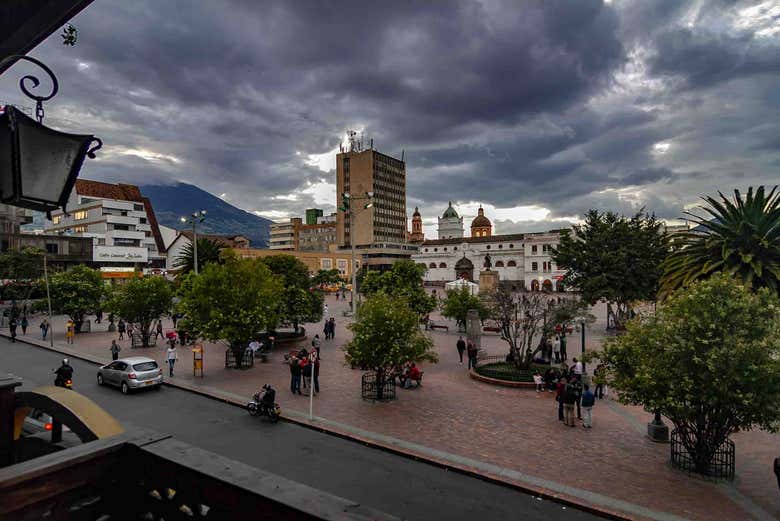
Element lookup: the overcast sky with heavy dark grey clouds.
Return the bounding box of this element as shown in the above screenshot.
[0,0,780,236]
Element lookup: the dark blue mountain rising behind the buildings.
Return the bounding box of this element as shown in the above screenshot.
[140,183,271,248]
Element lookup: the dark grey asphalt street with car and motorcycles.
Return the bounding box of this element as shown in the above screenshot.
[0,338,599,521]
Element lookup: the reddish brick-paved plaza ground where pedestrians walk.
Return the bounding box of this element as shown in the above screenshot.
[12,297,780,520]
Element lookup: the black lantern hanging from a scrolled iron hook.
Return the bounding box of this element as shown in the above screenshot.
[0,55,103,217]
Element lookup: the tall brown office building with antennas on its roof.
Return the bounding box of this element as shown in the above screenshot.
[336,139,417,268]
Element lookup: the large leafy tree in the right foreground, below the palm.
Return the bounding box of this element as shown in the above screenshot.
[600,274,780,474]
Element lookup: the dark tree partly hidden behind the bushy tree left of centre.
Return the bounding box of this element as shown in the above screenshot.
[262,255,323,331]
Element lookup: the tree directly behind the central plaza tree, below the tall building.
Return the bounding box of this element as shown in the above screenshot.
[360,260,436,318]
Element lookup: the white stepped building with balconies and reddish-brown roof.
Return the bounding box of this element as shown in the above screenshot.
[44,179,165,272]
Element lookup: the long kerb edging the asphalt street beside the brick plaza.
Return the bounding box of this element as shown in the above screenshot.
[6,333,639,521]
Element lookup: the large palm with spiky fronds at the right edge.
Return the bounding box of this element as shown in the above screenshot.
[660,186,780,297]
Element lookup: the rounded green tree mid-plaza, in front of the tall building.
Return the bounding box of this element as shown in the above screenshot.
[343,292,438,394]
